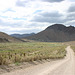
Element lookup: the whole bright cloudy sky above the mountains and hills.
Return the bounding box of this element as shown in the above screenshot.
[0,0,75,34]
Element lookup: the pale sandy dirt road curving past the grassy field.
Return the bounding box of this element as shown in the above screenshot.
[2,46,75,75]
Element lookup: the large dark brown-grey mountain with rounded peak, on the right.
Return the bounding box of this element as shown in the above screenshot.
[26,24,75,42]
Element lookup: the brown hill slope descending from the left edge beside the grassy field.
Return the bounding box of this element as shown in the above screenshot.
[0,32,23,42]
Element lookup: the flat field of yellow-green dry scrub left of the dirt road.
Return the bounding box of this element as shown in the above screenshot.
[0,42,66,65]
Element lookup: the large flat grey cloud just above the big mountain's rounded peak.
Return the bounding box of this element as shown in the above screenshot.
[31,12,64,23]
